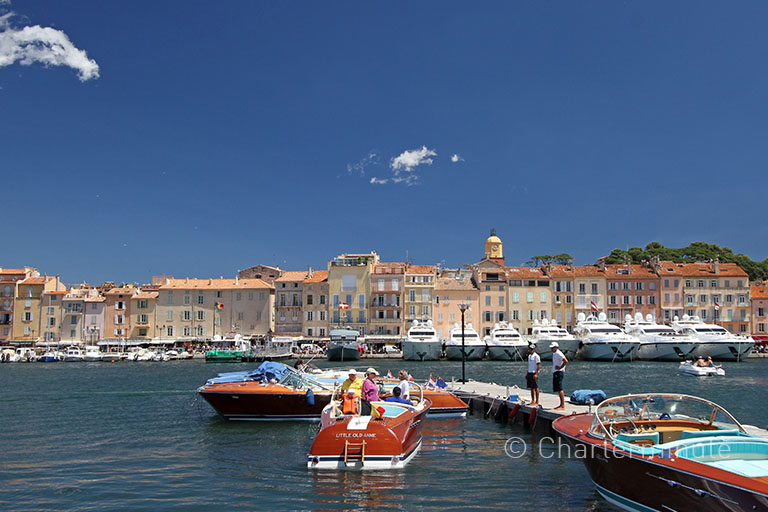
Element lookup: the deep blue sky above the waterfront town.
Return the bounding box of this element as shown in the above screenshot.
[0,0,768,282]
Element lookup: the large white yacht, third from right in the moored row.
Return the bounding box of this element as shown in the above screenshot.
[575,313,640,362]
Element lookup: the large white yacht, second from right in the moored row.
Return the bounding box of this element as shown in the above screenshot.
[624,313,698,361]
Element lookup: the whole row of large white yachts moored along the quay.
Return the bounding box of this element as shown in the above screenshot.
[403,313,754,362]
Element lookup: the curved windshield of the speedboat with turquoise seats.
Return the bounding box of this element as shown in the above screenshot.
[590,393,744,437]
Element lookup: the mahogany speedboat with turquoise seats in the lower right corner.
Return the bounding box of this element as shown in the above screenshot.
[553,393,768,511]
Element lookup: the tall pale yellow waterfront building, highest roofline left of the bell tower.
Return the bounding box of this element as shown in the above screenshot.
[328,251,379,335]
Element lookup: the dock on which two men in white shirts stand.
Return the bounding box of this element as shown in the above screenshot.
[446,380,768,438]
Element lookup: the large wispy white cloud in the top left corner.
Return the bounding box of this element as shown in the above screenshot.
[0,4,99,82]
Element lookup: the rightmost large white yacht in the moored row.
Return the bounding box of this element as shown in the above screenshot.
[672,315,755,361]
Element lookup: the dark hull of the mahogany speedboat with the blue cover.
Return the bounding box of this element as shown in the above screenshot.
[198,382,331,421]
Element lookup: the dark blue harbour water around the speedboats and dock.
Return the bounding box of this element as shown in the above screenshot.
[0,360,768,511]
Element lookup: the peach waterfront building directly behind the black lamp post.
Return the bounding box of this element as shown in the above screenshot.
[432,268,480,339]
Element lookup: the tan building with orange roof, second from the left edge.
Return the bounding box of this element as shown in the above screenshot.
[10,276,66,344]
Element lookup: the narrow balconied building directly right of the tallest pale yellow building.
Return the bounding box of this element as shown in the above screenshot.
[368,262,406,336]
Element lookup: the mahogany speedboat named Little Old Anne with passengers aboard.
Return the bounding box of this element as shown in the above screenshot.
[307,386,432,469]
